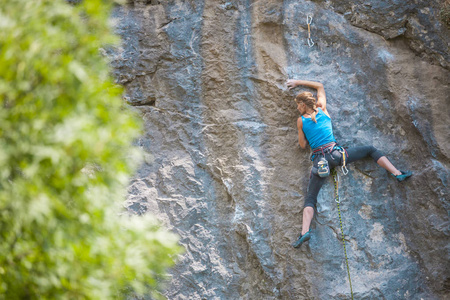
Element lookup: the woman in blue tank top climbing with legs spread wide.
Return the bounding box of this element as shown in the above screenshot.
[287,79,412,248]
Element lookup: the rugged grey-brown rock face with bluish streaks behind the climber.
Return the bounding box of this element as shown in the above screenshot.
[108,0,450,299]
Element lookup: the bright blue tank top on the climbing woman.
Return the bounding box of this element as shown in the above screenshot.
[302,108,336,149]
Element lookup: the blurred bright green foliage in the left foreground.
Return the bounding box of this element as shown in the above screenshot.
[0,0,180,299]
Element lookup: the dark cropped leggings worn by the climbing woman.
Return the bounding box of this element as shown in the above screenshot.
[304,146,383,208]
